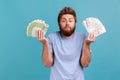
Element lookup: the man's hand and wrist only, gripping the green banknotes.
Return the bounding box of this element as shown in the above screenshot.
[36,30,48,45]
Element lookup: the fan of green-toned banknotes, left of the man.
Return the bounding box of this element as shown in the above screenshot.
[27,19,48,37]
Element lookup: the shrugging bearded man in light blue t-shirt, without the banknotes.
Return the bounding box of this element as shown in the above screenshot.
[37,7,96,80]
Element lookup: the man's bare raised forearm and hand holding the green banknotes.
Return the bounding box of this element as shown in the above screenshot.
[36,30,53,67]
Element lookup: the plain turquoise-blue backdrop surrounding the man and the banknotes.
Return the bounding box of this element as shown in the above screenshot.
[0,0,120,80]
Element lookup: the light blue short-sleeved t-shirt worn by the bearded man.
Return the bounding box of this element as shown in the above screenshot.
[47,32,86,80]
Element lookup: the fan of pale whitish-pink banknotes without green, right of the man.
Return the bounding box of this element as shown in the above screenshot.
[83,17,106,36]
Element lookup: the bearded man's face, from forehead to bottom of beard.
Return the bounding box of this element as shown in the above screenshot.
[59,14,76,37]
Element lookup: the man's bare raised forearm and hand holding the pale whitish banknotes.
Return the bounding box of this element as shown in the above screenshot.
[80,33,96,67]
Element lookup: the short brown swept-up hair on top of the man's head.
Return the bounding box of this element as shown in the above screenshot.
[58,7,77,23]
